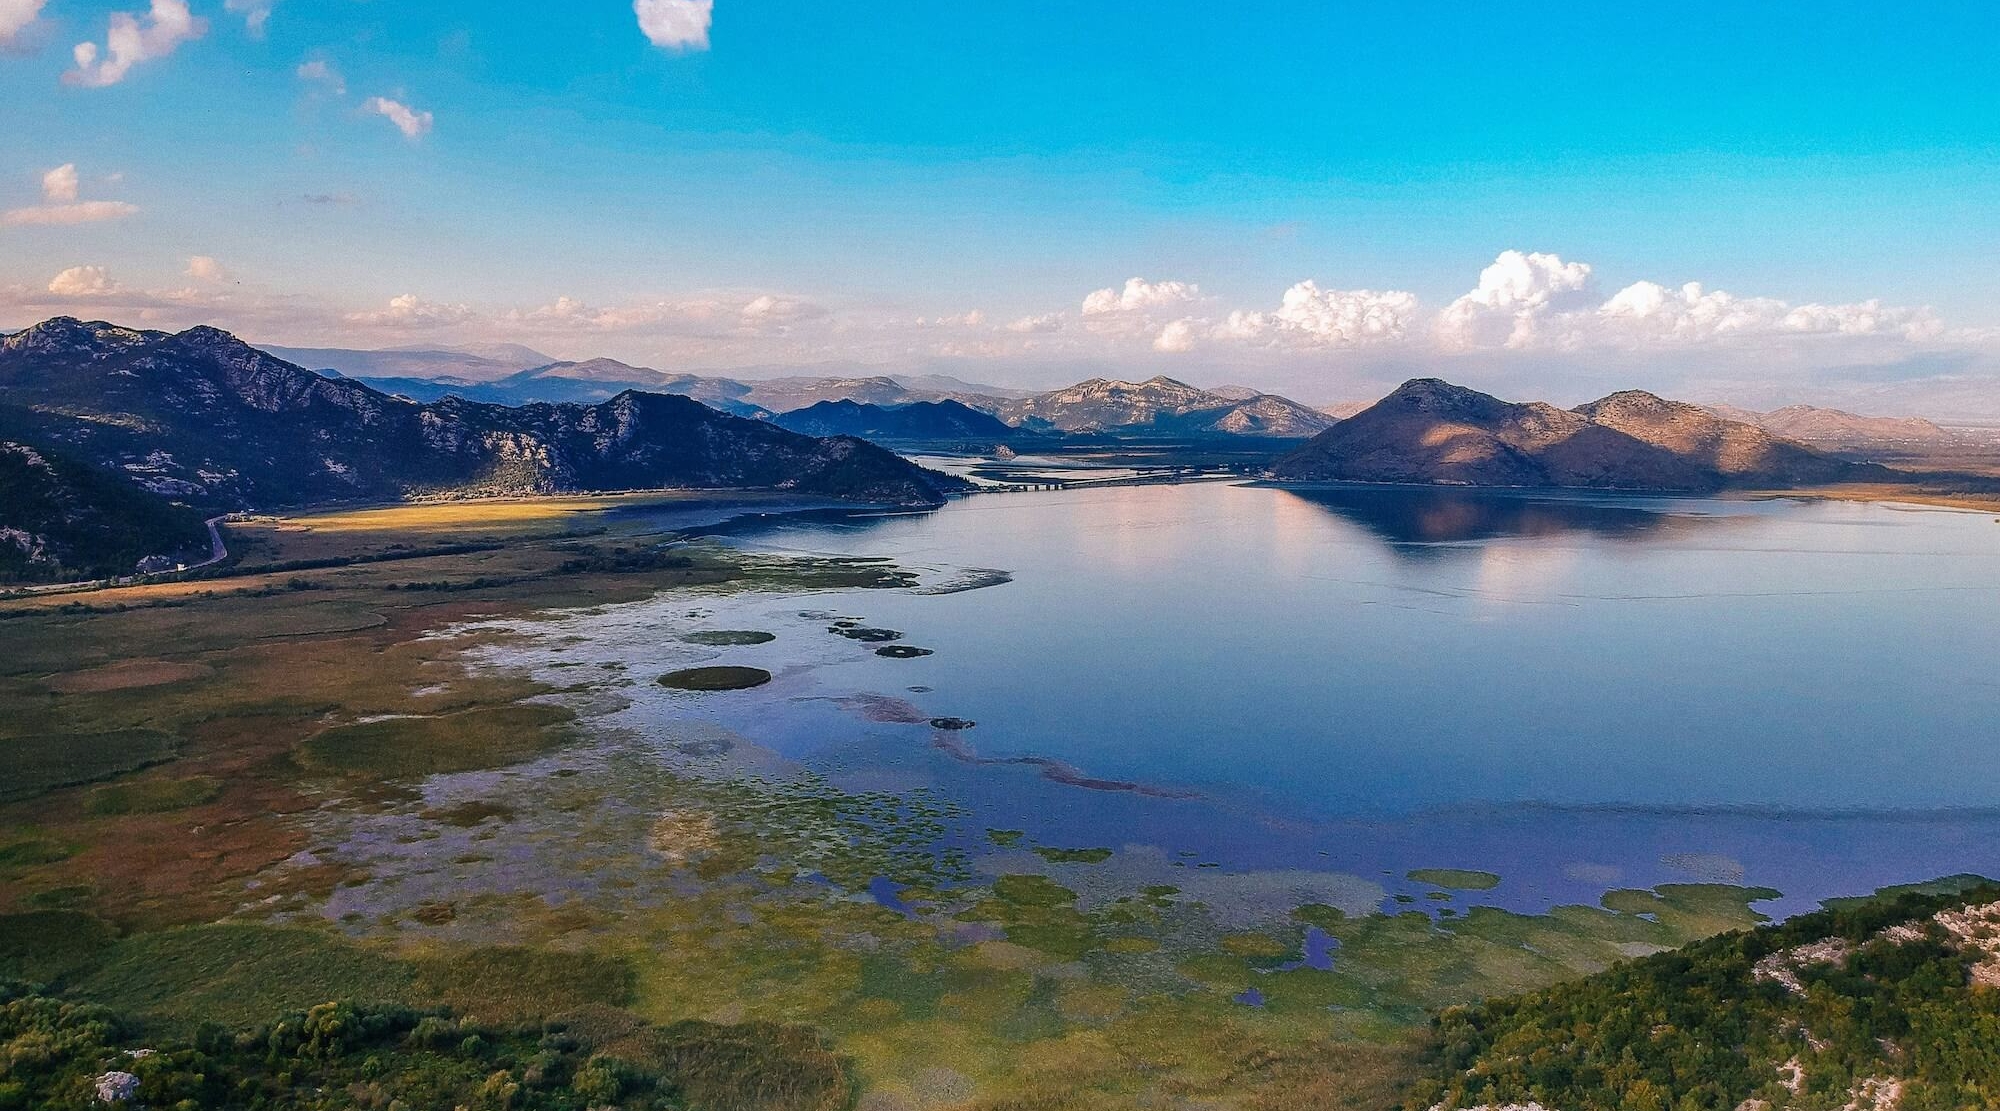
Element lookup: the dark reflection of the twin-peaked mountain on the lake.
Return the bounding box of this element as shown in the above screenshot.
[1282,486,1702,556]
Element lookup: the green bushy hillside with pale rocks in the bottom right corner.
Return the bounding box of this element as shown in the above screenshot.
[1406,877,2000,1111]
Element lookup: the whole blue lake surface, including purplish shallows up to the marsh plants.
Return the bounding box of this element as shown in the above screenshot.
[524,484,2000,909]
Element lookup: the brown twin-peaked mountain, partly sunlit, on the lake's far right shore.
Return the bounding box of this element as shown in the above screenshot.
[1272,378,1890,492]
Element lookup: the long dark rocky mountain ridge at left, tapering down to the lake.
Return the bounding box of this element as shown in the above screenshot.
[0,318,958,510]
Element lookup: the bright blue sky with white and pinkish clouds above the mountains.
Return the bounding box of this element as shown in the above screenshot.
[0,0,2000,418]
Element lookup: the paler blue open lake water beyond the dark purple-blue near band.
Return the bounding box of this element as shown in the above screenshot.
[696,484,2000,811]
